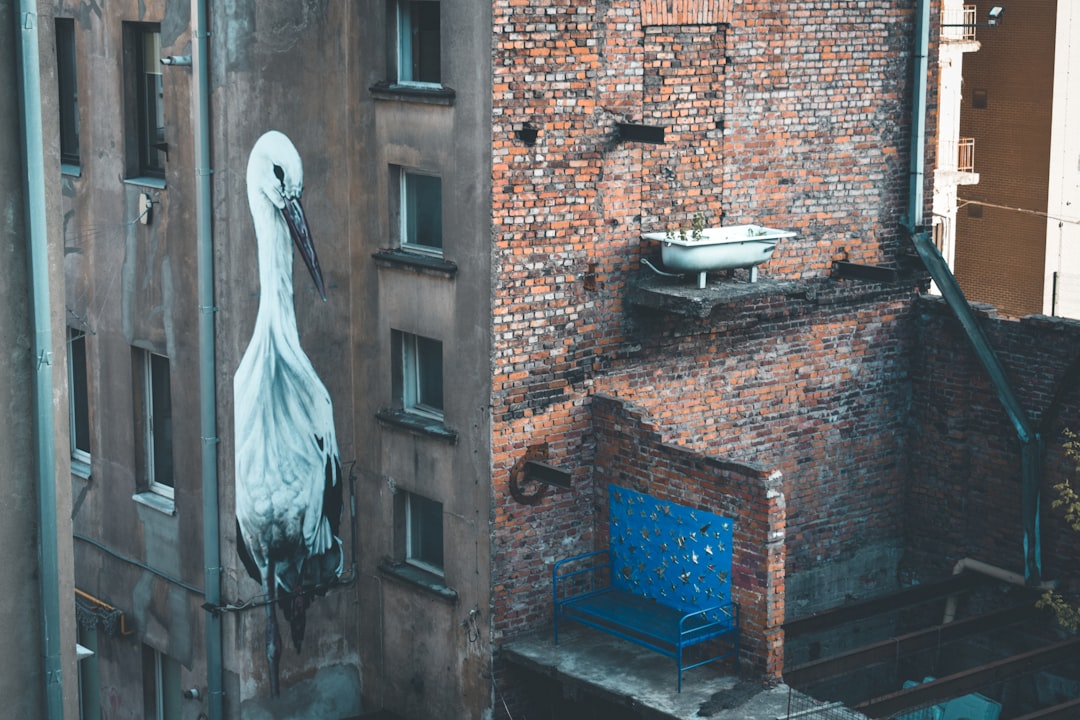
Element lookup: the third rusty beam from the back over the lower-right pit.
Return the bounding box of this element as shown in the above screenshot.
[854,638,1080,718]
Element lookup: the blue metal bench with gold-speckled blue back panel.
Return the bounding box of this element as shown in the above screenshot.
[552,486,739,692]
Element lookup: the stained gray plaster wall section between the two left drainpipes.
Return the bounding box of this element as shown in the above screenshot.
[55,0,232,720]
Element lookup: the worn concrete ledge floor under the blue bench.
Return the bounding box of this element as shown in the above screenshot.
[502,624,856,720]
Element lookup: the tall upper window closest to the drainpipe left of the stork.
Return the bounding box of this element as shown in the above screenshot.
[125,23,168,178]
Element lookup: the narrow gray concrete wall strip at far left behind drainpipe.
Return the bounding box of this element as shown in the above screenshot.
[0,2,79,719]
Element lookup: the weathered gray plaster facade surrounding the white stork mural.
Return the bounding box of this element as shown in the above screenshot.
[58,0,491,718]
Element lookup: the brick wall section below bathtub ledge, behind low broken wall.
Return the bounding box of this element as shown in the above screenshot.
[609,283,910,578]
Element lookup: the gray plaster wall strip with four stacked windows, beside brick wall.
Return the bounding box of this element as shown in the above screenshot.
[350,0,494,718]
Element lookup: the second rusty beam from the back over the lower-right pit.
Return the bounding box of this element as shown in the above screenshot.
[784,604,1038,688]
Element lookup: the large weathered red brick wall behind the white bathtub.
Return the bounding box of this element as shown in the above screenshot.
[490,0,937,708]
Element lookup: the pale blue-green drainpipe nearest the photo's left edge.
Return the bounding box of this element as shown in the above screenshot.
[18,0,64,720]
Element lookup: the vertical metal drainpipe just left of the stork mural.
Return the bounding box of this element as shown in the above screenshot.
[191,0,224,720]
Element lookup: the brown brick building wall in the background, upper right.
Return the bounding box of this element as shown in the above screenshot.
[955,0,1054,315]
